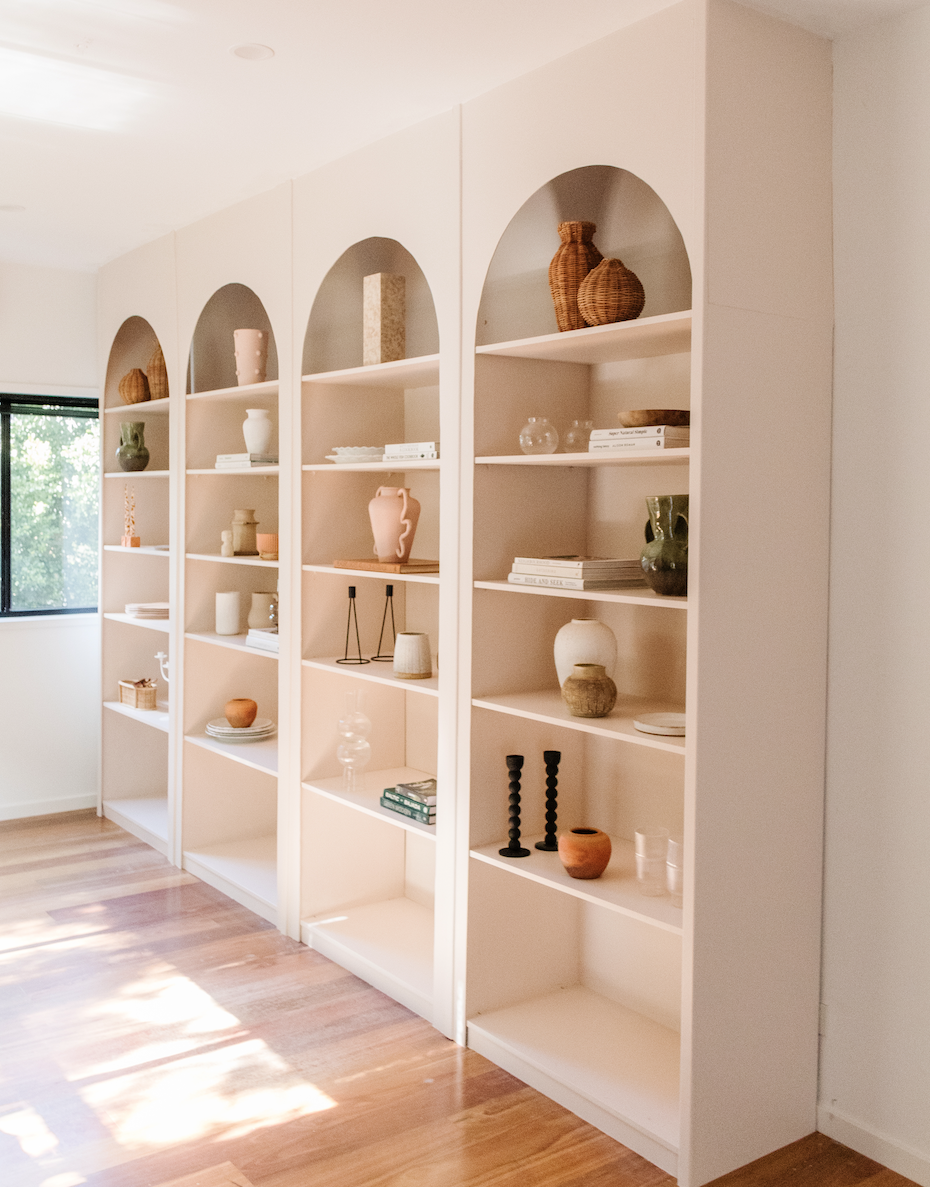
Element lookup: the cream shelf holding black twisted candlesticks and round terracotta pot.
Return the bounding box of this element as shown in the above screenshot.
[472,833,682,935]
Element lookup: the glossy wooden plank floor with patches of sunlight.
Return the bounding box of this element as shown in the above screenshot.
[0,813,909,1187]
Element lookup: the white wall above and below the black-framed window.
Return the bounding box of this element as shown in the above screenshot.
[0,262,100,820]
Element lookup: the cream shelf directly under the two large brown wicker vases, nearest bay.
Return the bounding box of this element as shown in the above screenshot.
[475,310,691,363]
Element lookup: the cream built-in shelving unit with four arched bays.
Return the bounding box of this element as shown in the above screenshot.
[100,0,830,1187]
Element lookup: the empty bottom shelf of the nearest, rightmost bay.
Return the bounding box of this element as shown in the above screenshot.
[468,985,681,1174]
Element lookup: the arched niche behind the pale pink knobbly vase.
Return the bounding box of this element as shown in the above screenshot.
[188,284,278,395]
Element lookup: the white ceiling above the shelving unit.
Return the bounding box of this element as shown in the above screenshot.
[0,0,920,269]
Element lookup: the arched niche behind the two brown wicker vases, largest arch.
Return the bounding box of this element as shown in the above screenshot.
[475,165,691,347]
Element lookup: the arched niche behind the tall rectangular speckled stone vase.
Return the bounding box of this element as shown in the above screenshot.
[300,237,439,375]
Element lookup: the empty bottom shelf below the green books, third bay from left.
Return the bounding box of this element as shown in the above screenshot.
[300,899,434,1017]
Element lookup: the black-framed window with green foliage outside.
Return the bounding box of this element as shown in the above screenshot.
[0,395,100,617]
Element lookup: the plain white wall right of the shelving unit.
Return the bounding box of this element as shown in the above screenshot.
[821,7,930,1185]
